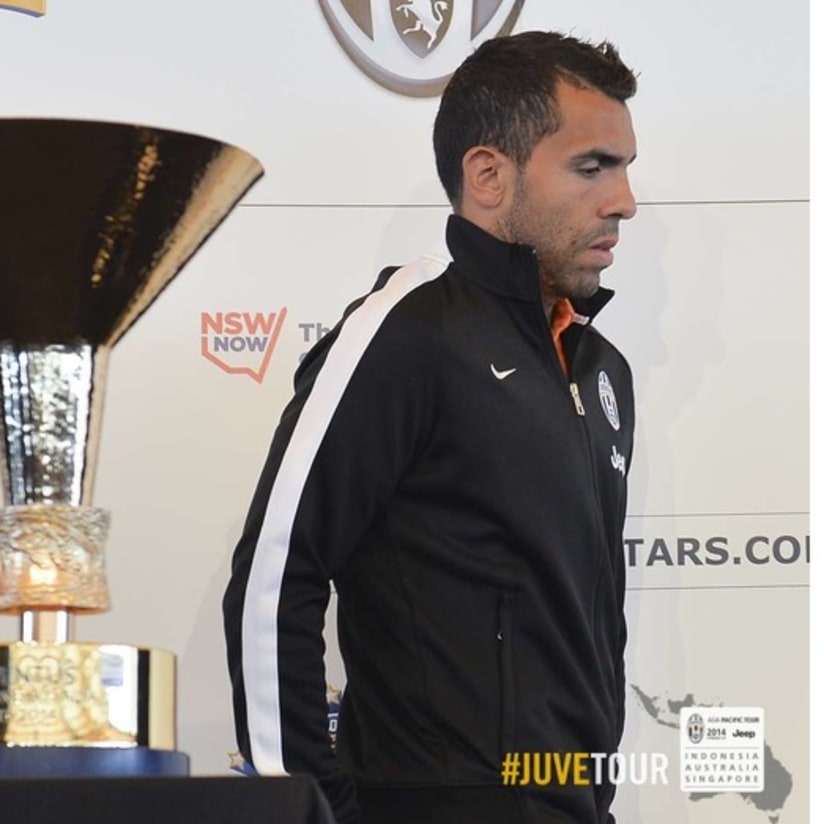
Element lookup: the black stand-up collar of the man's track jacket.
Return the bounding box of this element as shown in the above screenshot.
[446,214,615,323]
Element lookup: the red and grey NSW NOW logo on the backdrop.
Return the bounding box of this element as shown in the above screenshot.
[200,306,286,383]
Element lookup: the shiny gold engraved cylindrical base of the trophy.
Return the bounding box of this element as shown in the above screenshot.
[0,641,180,760]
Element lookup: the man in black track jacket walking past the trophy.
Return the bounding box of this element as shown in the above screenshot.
[224,32,635,824]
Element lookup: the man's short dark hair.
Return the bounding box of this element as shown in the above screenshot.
[433,31,636,206]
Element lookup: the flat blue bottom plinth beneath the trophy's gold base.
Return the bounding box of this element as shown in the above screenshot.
[0,747,189,778]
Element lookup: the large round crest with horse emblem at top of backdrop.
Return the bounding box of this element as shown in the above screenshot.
[318,0,524,97]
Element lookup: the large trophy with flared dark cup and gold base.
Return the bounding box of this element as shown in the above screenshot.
[0,119,263,772]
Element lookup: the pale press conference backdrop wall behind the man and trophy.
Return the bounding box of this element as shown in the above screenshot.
[0,0,810,824]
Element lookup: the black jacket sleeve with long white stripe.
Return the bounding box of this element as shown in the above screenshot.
[223,259,444,824]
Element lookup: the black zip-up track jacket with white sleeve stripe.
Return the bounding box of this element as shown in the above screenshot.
[224,215,634,824]
